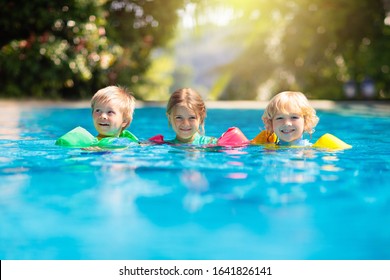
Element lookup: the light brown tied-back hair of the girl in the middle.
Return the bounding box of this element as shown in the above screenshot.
[167,88,206,134]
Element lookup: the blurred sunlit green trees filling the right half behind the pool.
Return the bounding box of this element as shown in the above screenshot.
[204,0,390,99]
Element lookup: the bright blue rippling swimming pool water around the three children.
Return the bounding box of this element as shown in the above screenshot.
[0,104,390,260]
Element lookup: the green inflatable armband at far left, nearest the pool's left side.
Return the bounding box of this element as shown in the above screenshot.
[55,126,98,148]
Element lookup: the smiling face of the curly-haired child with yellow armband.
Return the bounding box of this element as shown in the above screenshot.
[272,112,305,142]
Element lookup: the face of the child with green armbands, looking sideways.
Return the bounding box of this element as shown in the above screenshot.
[92,102,127,138]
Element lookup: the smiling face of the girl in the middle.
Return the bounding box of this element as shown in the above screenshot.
[168,105,200,143]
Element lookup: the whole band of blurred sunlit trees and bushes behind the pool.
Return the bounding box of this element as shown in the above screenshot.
[0,0,390,100]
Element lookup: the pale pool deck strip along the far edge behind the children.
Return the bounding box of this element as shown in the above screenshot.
[0,99,390,116]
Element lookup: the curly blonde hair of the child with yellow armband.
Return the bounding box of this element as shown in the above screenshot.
[262,91,319,135]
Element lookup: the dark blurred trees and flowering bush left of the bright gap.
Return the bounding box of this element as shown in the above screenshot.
[0,0,192,99]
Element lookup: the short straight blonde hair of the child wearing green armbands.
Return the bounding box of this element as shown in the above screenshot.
[91,86,135,130]
